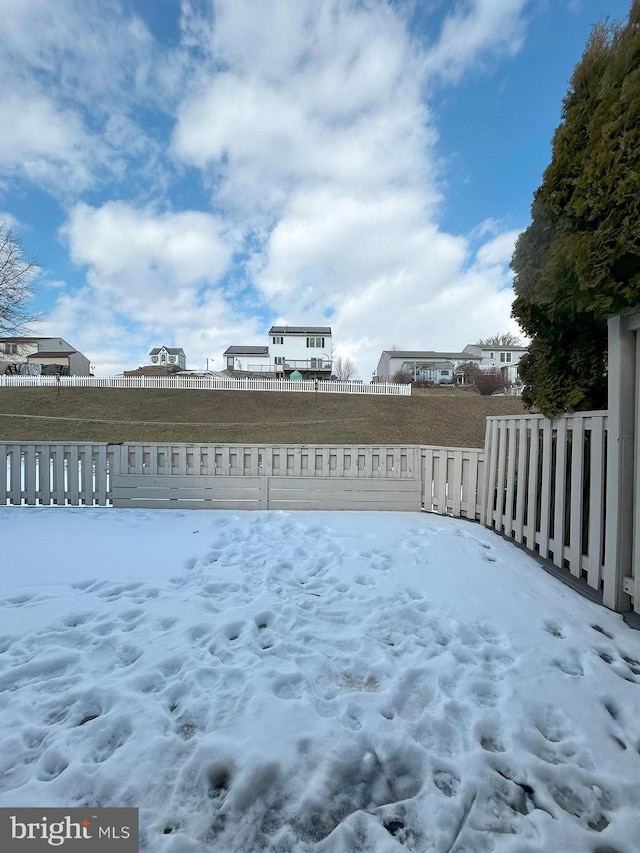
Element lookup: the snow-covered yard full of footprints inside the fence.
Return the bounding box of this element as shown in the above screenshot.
[0,507,640,853]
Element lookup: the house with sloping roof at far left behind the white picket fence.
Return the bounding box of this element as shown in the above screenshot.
[0,336,91,376]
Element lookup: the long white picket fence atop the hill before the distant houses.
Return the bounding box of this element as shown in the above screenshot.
[0,375,411,397]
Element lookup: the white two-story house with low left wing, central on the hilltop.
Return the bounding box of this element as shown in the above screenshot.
[224,326,332,379]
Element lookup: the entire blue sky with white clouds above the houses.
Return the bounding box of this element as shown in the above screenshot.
[0,0,630,380]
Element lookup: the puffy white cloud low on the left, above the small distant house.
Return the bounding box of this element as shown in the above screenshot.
[41,202,256,373]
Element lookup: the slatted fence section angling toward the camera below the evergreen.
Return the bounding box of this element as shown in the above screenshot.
[484,412,606,590]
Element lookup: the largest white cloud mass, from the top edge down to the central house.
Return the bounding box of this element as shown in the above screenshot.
[169,0,526,376]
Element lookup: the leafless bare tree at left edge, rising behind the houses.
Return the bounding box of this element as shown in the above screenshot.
[0,222,40,334]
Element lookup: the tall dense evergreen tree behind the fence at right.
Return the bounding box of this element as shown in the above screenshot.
[511,0,640,416]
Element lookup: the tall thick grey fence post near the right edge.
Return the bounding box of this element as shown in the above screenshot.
[603,314,637,611]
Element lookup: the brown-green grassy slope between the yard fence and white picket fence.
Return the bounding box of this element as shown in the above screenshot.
[0,387,524,447]
